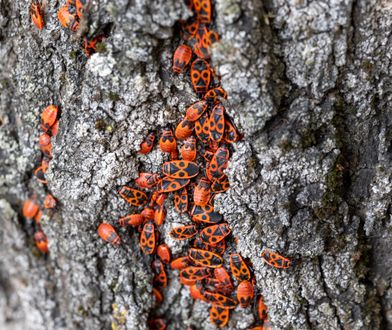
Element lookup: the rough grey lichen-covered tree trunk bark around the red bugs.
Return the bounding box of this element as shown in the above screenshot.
[0,0,392,329]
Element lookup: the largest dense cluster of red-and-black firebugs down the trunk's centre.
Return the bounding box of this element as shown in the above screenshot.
[98,0,291,330]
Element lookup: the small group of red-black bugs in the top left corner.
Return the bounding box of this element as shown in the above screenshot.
[30,0,109,56]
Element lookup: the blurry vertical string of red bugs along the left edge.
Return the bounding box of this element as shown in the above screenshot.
[22,105,59,253]
